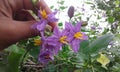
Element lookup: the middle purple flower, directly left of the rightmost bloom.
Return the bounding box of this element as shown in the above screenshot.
[47,27,68,54]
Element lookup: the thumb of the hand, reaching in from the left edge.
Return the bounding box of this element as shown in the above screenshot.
[0,18,37,50]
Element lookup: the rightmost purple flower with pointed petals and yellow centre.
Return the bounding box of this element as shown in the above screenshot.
[65,22,88,53]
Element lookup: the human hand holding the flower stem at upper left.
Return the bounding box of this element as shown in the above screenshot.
[0,0,56,50]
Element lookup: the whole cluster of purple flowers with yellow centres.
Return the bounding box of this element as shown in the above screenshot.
[33,10,88,64]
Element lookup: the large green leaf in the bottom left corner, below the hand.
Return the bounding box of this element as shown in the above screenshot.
[7,45,25,72]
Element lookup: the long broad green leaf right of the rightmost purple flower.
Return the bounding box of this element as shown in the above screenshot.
[88,34,114,53]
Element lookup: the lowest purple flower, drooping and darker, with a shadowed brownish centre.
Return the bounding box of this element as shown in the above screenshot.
[38,36,55,64]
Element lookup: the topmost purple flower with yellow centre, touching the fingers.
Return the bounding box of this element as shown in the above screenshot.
[32,10,58,31]
